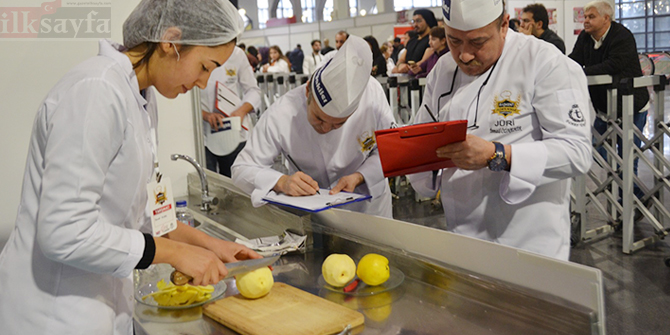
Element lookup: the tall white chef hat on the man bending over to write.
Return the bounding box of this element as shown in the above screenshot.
[310,35,372,118]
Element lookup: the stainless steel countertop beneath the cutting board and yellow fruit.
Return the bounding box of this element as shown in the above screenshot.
[135,210,595,335]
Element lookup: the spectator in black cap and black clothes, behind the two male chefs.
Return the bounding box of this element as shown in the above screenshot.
[393,8,437,73]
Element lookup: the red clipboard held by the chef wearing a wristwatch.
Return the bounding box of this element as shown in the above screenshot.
[375,120,468,177]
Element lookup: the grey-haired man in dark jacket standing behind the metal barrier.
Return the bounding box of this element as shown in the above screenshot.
[569,0,649,197]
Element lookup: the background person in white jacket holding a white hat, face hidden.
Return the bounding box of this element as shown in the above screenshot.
[200,41,261,177]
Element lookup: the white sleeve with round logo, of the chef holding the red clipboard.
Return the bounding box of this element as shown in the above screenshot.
[500,53,592,204]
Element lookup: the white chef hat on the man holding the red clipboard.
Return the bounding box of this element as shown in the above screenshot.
[442,0,503,31]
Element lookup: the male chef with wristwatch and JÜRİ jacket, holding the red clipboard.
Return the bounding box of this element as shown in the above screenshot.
[409,0,591,260]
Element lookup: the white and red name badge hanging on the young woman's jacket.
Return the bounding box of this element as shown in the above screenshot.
[147,177,177,236]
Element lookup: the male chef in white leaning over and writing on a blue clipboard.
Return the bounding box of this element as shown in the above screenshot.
[233,36,394,218]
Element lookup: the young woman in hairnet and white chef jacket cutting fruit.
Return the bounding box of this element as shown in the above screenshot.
[0,0,260,334]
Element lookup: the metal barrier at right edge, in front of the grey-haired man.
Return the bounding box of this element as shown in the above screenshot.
[571,75,670,254]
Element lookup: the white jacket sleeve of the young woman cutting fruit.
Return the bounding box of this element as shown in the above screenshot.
[36,79,145,277]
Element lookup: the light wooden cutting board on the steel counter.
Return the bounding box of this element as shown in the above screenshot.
[204,283,365,335]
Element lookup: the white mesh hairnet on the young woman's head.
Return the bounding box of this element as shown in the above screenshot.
[123,0,244,49]
